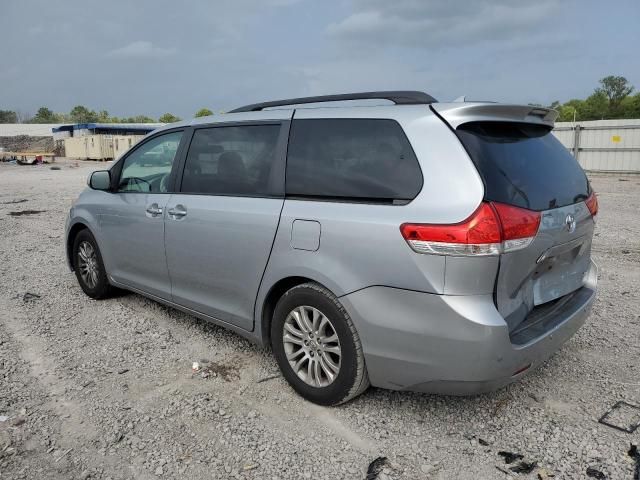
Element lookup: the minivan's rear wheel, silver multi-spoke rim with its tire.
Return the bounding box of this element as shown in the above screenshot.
[271,283,369,405]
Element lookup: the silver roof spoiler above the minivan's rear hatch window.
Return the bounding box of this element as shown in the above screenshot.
[431,102,558,129]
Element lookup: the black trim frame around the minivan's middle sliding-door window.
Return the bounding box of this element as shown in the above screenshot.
[174,119,291,198]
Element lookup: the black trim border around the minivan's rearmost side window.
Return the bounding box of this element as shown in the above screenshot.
[284,116,424,207]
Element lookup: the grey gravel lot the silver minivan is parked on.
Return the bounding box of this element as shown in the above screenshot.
[0,161,640,479]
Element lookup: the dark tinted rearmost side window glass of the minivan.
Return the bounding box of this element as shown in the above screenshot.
[286,119,422,203]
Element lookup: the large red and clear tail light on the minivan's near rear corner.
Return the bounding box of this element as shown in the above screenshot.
[400,202,540,256]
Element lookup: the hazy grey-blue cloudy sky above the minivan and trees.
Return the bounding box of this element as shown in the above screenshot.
[0,0,640,118]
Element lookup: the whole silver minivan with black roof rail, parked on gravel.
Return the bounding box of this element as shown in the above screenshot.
[66,91,598,405]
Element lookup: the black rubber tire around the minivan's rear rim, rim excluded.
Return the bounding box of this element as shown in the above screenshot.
[271,283,369,405]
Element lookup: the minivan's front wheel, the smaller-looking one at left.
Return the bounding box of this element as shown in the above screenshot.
[73,230,113,299]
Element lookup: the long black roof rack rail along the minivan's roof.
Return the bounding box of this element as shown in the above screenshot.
[229,90,437,113]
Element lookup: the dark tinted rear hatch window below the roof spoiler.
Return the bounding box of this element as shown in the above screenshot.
[456,122,589,211]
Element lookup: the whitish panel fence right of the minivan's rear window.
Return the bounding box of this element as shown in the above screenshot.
[553,119,640,173]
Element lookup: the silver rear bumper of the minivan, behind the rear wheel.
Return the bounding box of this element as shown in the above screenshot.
[341,263,597,395]
